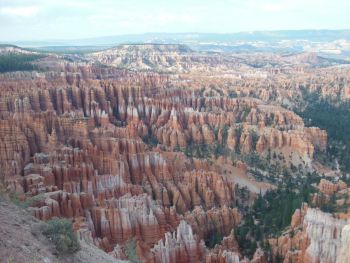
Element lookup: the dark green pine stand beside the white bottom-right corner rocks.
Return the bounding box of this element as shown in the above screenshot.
[235,175,318,257]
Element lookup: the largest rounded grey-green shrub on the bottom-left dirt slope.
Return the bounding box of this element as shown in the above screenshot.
[43,218,79,254]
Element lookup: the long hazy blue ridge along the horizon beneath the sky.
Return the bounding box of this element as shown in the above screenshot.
[4,29,350,46]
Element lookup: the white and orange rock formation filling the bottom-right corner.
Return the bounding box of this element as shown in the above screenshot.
[272,205,349,263]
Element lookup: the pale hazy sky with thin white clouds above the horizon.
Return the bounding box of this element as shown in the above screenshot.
[0,0,350,41]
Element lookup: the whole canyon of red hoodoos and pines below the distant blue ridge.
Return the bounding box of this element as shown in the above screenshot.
[0,43,350,263]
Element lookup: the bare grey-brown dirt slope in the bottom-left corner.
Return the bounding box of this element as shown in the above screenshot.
[0,200,123,263]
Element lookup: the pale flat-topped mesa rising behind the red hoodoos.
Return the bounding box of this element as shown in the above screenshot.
[88,44,238,72]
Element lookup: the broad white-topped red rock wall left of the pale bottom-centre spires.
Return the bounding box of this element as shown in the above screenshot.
[87,195,178,250]
